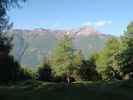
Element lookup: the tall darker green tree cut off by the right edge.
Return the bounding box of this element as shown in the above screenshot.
[115,22,133,77]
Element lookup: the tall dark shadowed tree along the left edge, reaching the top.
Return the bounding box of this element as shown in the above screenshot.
[0,0,25,83]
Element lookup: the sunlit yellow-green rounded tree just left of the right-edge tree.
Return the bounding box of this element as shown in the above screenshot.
[96,37,120,79]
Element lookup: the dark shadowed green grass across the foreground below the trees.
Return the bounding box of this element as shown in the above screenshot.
[0,80,133,100]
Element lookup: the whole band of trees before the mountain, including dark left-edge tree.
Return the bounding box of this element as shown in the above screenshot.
[0,0,133,84]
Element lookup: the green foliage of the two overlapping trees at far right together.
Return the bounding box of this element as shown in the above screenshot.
[92,22,133,80]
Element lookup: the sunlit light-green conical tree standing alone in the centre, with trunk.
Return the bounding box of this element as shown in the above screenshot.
[51,35,81,83]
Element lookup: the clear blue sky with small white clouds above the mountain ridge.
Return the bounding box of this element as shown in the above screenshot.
[9,0,133,36]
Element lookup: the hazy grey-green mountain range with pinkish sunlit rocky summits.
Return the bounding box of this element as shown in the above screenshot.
[10,26,110,66]
